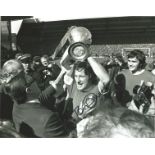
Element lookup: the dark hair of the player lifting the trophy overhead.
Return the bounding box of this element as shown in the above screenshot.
[74,61,97,84]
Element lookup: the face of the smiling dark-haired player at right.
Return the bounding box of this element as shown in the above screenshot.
[128,57,140,73]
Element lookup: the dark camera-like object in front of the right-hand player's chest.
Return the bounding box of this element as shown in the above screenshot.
[133,81,153,114]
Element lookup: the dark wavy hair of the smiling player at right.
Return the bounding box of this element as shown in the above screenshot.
[127,49,146,69]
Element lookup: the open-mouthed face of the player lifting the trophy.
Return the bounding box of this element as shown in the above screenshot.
[74,69,89,91]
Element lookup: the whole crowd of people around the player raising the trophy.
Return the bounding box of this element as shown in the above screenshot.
[0,26,155,138]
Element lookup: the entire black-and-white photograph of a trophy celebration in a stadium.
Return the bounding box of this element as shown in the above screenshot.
[0,0,155,154]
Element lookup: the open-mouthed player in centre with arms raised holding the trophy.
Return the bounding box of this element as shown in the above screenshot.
[68,57,109,121]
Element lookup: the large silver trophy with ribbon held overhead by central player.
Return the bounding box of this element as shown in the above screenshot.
[52,26,92,61]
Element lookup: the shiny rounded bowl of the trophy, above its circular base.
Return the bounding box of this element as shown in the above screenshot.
[69,27,92,44]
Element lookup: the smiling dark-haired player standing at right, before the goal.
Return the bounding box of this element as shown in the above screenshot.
[115,49,155,115]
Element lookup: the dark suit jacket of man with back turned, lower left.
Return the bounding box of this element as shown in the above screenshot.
[13,88,67,137]
